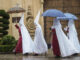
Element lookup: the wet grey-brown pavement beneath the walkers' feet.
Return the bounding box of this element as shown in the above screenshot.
[0,54,80,60]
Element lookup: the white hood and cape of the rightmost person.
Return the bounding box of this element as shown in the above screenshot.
[67,20,80,53]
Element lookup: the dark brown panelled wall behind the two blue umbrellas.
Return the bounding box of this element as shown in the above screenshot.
[43,0,80,43]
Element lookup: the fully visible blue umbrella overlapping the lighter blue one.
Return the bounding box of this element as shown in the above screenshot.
[42,9,65,17]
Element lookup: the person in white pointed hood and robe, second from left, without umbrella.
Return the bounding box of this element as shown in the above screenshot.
[34,11,48,54]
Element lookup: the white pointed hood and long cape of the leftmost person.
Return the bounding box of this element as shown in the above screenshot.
[19,14,34,54]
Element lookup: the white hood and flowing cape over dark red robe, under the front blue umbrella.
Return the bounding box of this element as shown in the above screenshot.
[53,20,78,57]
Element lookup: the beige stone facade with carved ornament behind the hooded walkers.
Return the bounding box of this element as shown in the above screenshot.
[0,0,44,40]
